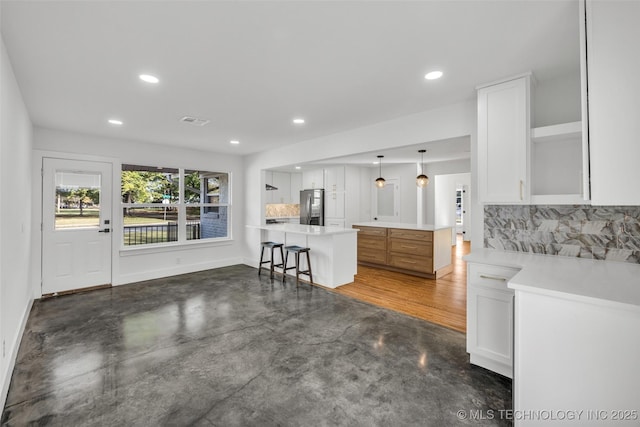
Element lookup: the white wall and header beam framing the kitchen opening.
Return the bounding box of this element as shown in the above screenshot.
[245,102,476,265]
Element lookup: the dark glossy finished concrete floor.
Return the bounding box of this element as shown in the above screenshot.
[2,265,511,426]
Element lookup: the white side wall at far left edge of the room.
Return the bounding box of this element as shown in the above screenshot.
[0,39,33,408]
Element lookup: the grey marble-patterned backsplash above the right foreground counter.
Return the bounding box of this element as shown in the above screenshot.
[484,205,640,263]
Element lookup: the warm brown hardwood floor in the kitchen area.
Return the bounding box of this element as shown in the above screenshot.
[335,236,470,332]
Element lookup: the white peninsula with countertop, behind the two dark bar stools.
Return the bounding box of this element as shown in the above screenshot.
[247,224,358,288]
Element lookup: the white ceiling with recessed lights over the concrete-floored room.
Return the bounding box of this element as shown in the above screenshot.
[1,0,579,161]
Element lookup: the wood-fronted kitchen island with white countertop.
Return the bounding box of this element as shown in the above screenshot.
[353,221,453,279]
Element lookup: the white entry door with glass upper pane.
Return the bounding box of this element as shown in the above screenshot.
[42,158,112,295]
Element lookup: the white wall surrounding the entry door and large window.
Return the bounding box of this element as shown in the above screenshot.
[32,128,245,288]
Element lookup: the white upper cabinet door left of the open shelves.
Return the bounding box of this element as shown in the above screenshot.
[478,74,531,203]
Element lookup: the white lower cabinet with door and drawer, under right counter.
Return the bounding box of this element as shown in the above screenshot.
[467,263,519,378]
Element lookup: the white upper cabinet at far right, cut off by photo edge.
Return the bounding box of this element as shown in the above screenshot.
[586,1,640,205]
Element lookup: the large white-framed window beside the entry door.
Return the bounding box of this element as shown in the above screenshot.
[121,165,230,246]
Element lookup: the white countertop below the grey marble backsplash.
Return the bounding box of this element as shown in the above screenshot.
[463,249,640,311]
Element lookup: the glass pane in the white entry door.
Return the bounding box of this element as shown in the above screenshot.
[55,171,101,230]
